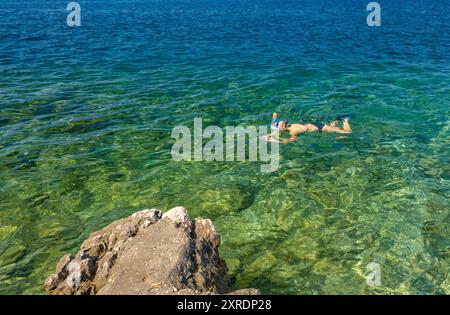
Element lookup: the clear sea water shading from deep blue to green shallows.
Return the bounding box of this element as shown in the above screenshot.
[0,0,450,294]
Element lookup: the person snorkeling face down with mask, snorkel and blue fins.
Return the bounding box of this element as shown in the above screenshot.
[264,113,354,143]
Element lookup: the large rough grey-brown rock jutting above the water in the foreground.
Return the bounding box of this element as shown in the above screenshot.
[44,207,259,294]
